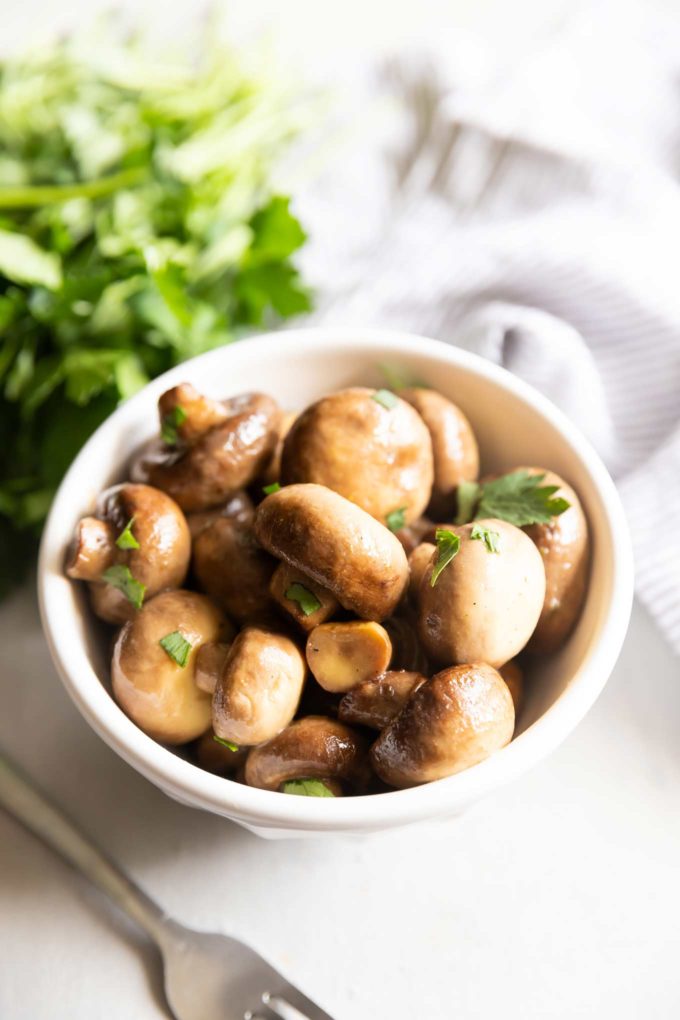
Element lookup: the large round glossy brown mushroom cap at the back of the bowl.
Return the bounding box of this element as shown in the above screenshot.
[281,387,432,524]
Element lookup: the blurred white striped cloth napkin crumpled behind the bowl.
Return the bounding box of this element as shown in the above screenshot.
[300,2,680,653]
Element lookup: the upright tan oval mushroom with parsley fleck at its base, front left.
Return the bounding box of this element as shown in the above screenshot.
[212,626,306,747]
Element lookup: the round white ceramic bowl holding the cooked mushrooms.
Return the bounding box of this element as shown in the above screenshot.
[39,329,633,836]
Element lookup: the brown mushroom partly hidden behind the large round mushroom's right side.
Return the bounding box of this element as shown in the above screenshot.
[399,387,479,517]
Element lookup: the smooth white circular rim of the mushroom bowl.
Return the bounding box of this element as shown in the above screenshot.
[38,326,633,832]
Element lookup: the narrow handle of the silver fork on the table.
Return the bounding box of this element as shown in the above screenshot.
[0,754,169,944]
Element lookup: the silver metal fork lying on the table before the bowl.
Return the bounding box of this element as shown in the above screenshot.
[0,755,332,1020]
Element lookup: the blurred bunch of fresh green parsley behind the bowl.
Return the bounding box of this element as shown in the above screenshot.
[0,29,310,592]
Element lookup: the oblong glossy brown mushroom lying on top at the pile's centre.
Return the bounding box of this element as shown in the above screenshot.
[254,485,409,620]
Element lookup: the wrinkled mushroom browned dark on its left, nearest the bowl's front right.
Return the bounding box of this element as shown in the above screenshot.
[371,662,515,787]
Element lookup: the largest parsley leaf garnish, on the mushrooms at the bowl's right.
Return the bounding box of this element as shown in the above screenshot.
[475,471,569,527]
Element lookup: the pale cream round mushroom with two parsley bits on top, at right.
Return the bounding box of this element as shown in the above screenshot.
[418,519,545,666]
